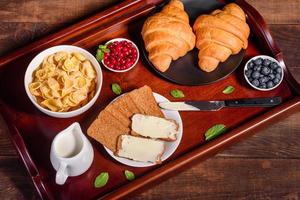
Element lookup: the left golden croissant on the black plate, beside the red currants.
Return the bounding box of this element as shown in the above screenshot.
[142,0,196,72]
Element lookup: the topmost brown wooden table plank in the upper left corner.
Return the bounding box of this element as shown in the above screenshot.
[0,0,120,24]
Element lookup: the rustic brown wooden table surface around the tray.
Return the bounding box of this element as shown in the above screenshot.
[0,0,300,200]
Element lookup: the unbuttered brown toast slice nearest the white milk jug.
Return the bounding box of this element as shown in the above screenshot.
[87,110,130,152]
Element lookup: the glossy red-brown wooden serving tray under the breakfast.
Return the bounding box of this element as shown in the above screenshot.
[0,0,300,200]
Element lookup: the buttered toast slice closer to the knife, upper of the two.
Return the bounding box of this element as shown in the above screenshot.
[131,114,178,140]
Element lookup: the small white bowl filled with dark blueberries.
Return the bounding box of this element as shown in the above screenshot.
[244,55,283,91]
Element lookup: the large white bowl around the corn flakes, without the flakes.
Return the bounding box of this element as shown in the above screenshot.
[24,45,103,118]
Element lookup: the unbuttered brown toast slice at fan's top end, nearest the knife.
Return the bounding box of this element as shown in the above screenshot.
[128,85,164,117]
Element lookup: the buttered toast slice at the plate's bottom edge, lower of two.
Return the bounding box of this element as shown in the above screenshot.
[116,135,165,163]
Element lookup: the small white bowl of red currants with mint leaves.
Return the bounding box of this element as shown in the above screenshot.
[96,38,139,72]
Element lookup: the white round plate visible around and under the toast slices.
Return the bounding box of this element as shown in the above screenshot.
[104,92,183,167]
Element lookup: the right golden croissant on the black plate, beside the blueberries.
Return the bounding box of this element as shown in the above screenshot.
[193,3,250,72]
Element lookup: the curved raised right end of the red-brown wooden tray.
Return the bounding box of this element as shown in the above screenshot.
[235,0,300,95]
